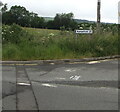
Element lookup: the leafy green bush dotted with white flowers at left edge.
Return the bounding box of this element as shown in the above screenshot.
[2,24,32,44]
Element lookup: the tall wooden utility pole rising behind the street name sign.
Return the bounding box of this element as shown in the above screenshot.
[97,0,101,33]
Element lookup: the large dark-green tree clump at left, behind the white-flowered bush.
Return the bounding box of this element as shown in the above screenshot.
[3,5,45,28]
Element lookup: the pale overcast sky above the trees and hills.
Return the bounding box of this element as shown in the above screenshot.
[2,0,120,23]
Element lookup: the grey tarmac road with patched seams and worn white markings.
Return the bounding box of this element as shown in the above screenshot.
[2,60,118,110]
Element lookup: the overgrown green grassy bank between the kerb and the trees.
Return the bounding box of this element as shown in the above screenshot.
[2,26,118,60]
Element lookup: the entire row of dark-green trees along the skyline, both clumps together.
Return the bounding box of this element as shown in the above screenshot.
[1,4,77,30]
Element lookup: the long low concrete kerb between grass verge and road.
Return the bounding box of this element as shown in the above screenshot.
[1,55,120,65]
